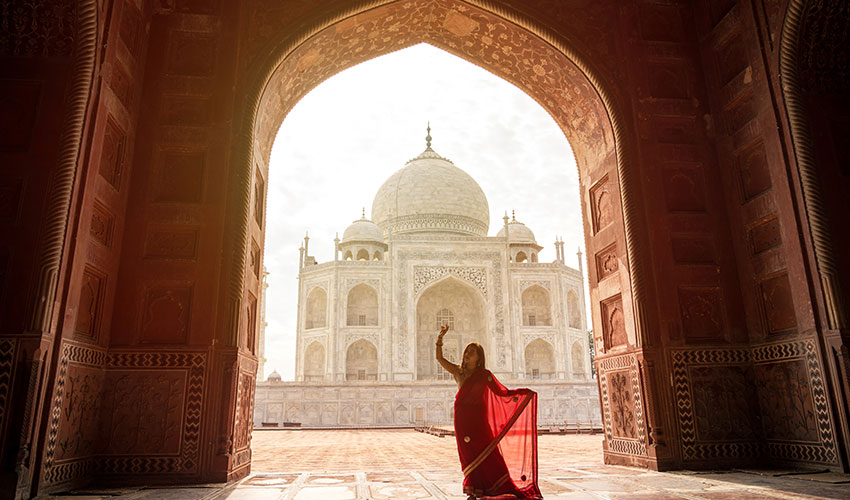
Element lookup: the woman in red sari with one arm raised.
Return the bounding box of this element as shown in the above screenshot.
[437,326,543,500]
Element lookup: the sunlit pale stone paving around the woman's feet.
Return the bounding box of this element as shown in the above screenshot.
[53,430,850,500]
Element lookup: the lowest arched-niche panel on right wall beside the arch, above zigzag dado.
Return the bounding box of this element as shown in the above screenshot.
[679,286,724,341]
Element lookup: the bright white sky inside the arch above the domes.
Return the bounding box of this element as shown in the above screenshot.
[263,44,590,380]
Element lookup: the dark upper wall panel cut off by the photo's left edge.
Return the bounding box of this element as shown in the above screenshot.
[0,79,41,151]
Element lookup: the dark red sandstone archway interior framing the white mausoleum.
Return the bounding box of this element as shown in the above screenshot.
[0,0,850,498]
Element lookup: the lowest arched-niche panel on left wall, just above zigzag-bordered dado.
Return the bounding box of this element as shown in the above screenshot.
[140,287,192,344]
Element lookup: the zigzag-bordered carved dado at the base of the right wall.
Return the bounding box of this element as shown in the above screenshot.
[670,339,838,464]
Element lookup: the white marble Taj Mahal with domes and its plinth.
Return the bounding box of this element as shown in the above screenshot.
[248,132,601,427]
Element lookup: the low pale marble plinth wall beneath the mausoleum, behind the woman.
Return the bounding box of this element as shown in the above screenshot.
[248,380,602,428]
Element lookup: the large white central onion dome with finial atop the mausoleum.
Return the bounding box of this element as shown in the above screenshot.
[372,143,490,236]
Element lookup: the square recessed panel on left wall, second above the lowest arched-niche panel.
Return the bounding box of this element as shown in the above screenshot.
[154,151,205,203]
